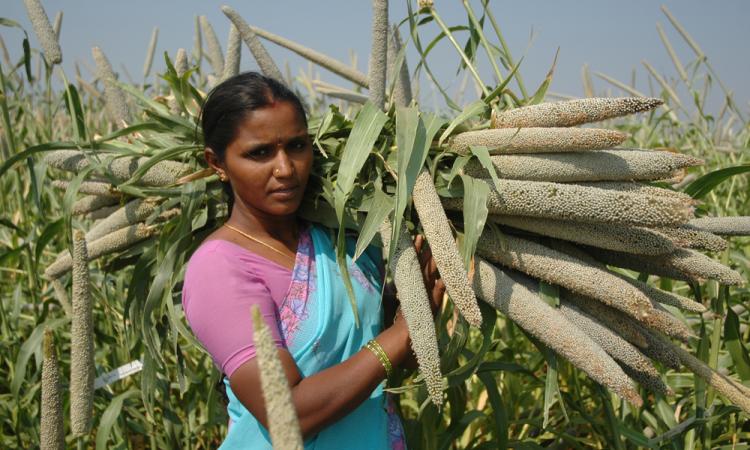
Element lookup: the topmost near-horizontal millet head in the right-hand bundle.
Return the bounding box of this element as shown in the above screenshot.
[492,97,664,128]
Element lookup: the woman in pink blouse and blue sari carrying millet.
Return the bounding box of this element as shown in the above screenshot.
[183,73,444,450]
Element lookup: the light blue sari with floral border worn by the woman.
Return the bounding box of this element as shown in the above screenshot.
[220,225,405,450]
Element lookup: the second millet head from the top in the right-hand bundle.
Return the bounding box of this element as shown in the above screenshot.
[448,128,628,155]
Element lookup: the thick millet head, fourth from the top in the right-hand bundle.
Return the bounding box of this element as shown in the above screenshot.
[443,179,693,226]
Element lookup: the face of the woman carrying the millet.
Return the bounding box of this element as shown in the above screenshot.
[217,101,313,221]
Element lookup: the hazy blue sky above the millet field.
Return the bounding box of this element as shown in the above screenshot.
[5,0,750,116]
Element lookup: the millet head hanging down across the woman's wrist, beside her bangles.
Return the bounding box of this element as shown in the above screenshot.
[380,220,443,406]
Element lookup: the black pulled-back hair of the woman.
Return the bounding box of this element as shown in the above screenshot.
[200,72,307,214]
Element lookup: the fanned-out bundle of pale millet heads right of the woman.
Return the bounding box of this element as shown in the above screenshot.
[432,98,750,411]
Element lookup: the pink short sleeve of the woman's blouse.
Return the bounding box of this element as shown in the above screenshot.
[182,242,286,376]
